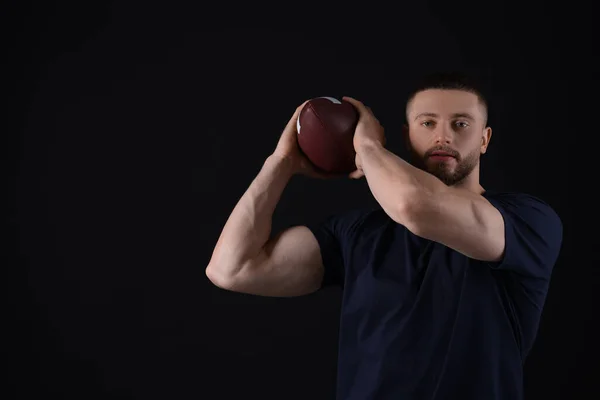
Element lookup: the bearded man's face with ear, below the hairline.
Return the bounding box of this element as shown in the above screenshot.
[407,89,491,186]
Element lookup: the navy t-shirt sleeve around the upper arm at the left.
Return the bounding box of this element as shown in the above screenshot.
[307,210,364,288]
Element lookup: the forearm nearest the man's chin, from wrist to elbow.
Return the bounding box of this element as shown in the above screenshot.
[358,143,444,227]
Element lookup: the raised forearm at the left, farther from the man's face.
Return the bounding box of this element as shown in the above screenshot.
[210,156,293,276]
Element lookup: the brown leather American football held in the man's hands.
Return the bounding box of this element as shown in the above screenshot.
[296,97,358,174]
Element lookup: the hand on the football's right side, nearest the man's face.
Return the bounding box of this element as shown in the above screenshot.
[342,96,385,179]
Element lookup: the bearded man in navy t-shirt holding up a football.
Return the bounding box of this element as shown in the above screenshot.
[206,75,562,400]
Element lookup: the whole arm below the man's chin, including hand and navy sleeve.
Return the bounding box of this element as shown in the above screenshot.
[344,97,562,268]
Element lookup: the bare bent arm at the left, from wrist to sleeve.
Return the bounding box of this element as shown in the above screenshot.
[206,155,324,297]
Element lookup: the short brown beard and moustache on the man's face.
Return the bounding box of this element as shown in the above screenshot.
[411,146,480,186]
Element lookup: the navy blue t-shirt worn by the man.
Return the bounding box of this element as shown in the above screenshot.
[309,192,562,400]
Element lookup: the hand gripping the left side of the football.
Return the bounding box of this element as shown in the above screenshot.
[272,100,338,179]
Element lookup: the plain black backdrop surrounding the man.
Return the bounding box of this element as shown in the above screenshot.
[3,2,600,399]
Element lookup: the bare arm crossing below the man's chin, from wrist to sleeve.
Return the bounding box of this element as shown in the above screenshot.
[357,141,505,262]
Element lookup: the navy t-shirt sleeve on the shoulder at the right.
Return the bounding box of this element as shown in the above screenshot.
[488,194,563,280]
